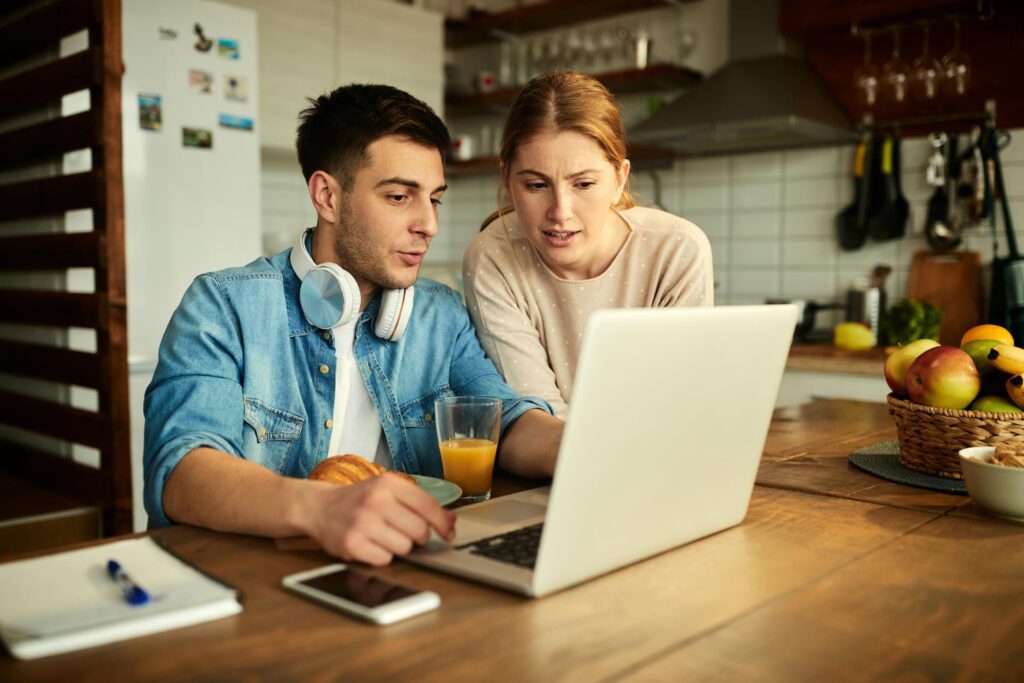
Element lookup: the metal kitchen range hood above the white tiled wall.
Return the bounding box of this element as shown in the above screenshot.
[630,0,856,155]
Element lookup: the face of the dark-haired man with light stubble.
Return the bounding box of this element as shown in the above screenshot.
[334,135,447,290]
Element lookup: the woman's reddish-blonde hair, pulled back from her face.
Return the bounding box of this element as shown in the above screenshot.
[480,71,636,229]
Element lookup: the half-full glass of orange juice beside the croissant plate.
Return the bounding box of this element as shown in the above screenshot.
[434,396,502,503]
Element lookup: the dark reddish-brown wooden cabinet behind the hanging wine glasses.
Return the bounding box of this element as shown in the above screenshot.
[779,0,1024,135]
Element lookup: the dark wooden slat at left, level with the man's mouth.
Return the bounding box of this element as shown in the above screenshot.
[0,232,105,270]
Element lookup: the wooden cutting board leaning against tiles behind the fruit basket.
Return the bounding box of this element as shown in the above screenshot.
[906,251,985,346]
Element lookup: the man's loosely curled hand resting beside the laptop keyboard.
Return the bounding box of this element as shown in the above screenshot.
[308,474,455,566]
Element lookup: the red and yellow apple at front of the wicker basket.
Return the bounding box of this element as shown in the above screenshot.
[906,344,981,411]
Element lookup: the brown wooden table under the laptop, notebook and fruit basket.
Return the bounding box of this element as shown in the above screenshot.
[0,400,1024,681]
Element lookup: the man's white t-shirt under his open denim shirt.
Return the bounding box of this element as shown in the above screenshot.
[327,317,394,469]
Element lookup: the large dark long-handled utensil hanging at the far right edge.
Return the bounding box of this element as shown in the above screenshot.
[982,128,1024,339]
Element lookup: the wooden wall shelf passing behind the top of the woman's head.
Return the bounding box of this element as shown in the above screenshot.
[444,65,703,117]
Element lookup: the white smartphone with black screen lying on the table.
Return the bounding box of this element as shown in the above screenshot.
[281,564,441,624]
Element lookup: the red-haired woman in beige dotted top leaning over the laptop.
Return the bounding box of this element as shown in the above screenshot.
[463,72,714,418]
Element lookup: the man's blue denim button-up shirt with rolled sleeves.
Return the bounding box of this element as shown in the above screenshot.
[143,249,551,527]
